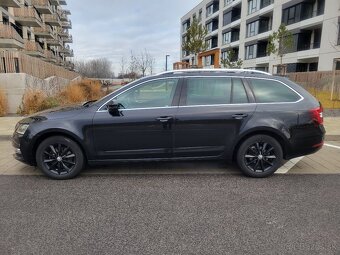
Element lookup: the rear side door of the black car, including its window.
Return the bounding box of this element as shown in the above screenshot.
[174,77,256,157]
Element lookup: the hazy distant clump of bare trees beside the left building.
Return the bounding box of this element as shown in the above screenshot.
[75,58,113,78]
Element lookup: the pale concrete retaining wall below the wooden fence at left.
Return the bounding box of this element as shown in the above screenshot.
[0,73,80,113]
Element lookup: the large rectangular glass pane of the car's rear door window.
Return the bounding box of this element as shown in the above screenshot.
[187,78,231,105]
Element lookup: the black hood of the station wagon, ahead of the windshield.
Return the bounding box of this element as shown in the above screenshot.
[20,104,86,123]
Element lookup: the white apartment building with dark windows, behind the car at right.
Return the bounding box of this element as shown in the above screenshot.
[181,0,340,72]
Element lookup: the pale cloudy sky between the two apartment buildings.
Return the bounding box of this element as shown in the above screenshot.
[64,0,201,75]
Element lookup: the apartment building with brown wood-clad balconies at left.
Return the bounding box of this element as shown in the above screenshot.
[0,0,74,73]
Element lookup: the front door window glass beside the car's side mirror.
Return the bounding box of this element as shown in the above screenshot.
[116,79,178,109]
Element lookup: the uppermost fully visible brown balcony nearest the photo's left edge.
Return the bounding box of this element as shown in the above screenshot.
[13,7,42,27]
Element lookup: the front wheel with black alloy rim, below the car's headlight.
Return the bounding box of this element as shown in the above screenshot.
[36,136,85,180]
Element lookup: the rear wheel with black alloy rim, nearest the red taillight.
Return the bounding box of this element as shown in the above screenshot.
[237,135,283,178]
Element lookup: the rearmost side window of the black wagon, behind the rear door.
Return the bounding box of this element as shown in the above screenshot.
[251,79,300,103]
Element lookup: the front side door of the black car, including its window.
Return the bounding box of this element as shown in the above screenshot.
[93,78,181,160]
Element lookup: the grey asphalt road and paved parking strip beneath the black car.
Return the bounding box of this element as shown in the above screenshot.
[0,140,340,255]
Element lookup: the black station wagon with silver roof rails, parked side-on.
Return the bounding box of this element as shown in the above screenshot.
[12,69,325,179]
